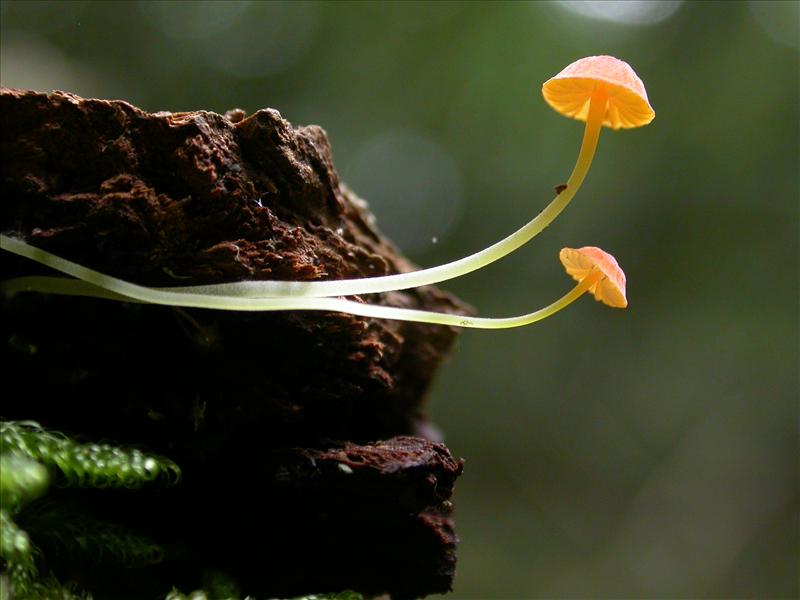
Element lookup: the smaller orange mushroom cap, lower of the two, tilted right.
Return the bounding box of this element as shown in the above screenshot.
[558,246,628,308]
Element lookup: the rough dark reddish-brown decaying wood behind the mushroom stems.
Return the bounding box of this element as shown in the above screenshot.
[0,89,468,597]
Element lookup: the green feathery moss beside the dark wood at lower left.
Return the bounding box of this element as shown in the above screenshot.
[0,421,180,600]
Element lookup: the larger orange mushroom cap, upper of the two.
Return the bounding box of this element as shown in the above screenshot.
[542,56,656,129]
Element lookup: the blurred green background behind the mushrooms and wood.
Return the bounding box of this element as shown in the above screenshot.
[0,0,800,599]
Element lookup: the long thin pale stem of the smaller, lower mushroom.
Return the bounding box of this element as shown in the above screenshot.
[0,269,603,329]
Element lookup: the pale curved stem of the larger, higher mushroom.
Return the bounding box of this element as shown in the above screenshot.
[92,87,608,298]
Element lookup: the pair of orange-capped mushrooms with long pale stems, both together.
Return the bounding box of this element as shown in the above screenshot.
[0,56,655,329]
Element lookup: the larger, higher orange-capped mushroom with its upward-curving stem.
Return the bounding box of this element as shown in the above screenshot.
[136,56,655,298]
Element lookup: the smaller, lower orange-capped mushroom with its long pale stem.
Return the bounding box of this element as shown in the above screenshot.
[0,236,628,329]
